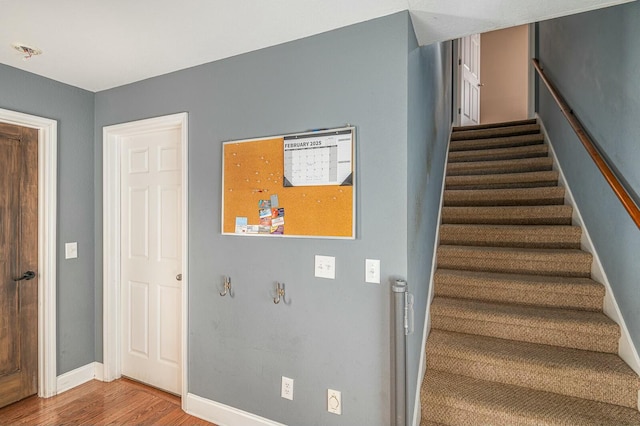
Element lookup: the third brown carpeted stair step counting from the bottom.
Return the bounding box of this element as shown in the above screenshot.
[431,296,620,353]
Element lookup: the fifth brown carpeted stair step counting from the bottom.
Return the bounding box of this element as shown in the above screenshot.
[437,244,593,277]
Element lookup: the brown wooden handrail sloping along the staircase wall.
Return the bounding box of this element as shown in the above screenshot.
[531,58,640,228]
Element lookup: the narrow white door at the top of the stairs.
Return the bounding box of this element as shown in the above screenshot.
[460,34,481,126]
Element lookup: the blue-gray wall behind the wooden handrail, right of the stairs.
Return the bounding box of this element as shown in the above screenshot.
[539,2,640,348]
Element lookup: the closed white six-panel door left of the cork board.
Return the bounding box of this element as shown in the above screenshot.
[120,129,182,394]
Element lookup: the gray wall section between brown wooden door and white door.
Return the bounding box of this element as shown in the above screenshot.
[0,64,95,375]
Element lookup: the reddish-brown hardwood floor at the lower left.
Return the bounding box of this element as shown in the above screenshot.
[0,378,215,426]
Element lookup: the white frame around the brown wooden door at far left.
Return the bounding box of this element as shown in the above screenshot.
[0,109,58,398]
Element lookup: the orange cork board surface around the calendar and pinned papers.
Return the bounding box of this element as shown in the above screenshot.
[222,128,355,239]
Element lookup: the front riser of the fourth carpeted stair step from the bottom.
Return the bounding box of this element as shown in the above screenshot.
[434,280,603,312]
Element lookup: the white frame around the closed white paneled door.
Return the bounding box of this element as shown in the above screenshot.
[102,112,189,402]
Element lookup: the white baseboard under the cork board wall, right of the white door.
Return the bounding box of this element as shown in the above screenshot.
[185,393,285,426]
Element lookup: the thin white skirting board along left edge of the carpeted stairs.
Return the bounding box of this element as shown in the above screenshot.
[407,123,453,426]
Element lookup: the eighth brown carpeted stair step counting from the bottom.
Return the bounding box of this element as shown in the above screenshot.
[444,186,565,207]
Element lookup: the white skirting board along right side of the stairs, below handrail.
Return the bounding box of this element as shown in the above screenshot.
[536,114,640,374]
